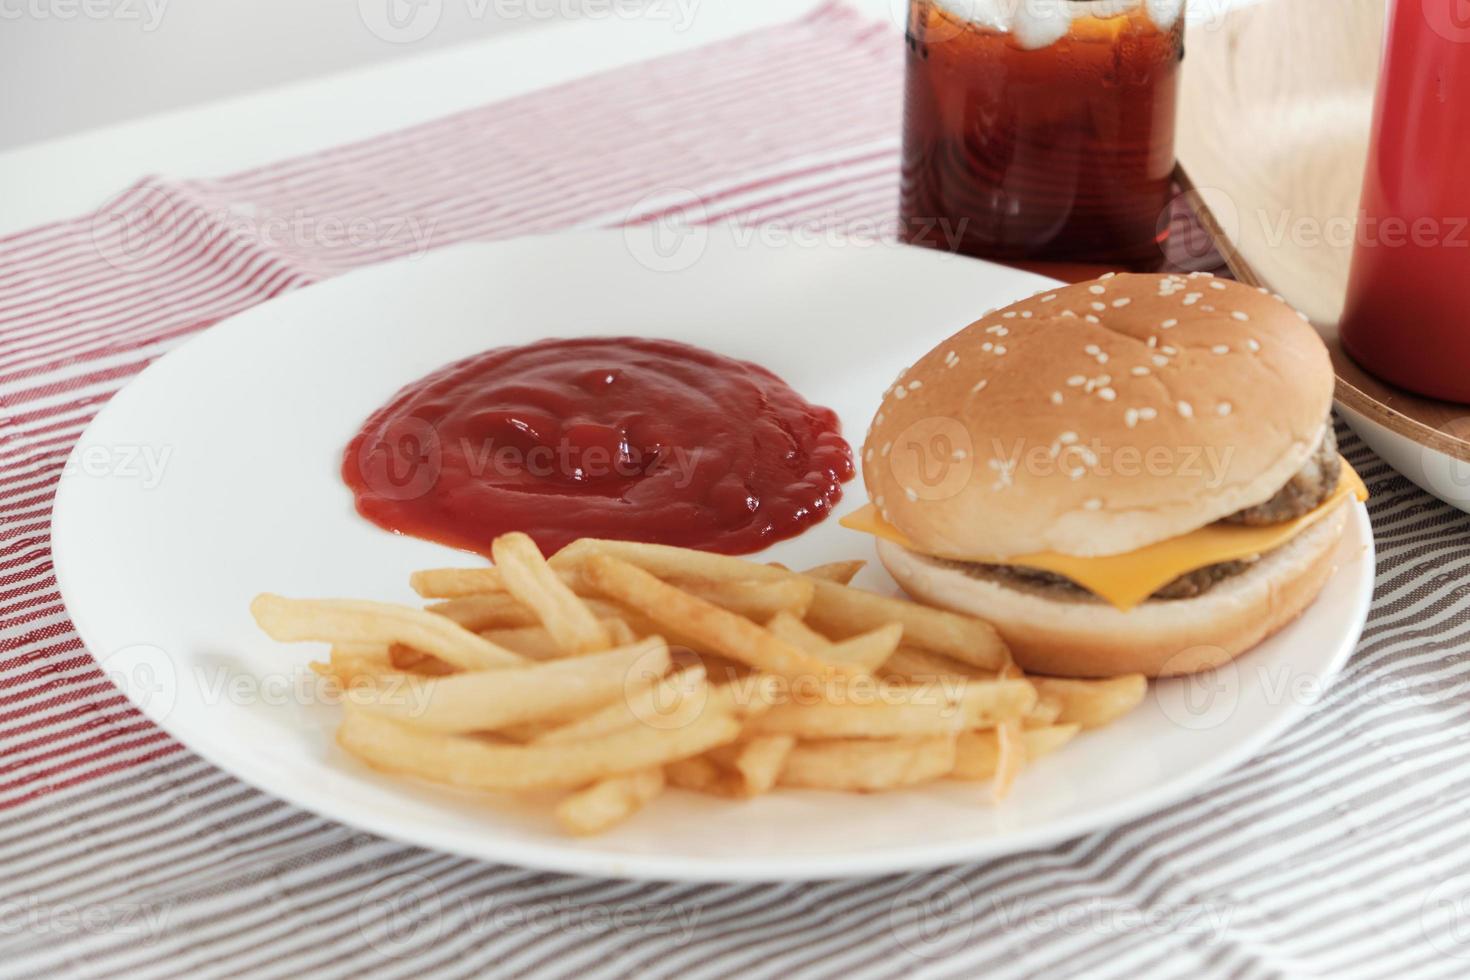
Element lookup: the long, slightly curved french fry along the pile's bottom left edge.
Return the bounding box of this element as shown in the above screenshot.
[337,704,741,792]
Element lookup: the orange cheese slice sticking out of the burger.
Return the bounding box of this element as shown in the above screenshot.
[841,460,1369,610]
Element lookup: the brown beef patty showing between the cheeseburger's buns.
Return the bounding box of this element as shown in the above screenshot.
[929,420,1342,599]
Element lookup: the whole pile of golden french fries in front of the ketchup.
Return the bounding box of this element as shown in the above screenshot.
[251,533,1147,835]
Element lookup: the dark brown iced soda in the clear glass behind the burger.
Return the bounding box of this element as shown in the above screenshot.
[901,0,1183,270]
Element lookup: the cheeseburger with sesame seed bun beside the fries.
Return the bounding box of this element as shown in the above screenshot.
[844,273,1366,677]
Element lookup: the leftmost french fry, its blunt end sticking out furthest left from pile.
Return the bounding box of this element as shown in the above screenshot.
[250,594,525,670]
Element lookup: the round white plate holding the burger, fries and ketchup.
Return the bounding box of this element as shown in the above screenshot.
[53,231,1373,880]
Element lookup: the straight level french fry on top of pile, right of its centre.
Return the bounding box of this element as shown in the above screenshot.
[745,680,1036,739]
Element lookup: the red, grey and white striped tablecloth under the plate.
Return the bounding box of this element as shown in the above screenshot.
[0,7,1470,977]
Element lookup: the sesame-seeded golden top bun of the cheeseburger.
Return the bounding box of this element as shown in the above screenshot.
[863,273,1333,558]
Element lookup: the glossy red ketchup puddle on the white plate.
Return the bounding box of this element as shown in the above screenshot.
[343,336,854,555]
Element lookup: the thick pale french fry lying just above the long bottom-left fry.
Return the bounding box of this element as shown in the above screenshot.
[348,636,669,733]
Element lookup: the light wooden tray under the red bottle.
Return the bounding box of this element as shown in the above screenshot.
[1179,0,1470,467]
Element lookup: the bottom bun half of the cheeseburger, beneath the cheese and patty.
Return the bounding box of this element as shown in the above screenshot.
[878,501,1351,677]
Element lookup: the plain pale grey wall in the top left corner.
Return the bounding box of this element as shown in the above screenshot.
[0,0,667,150]
